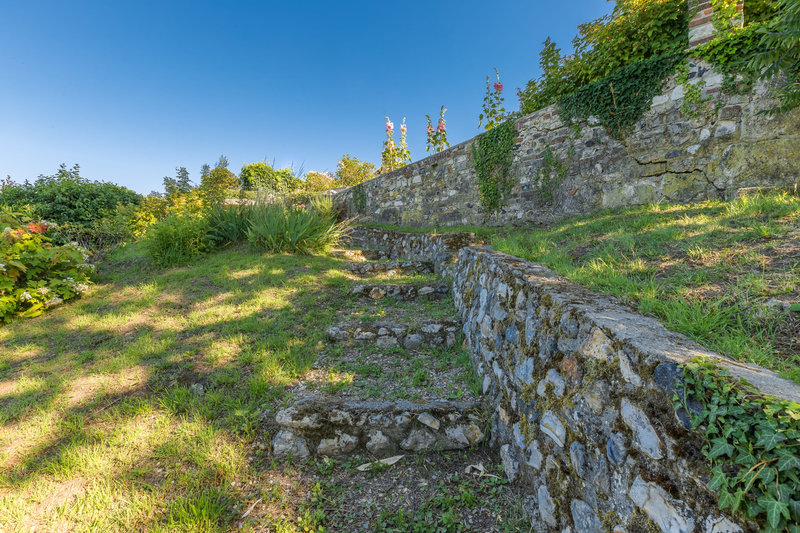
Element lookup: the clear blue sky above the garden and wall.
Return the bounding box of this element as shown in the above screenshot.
[0,0,613,193]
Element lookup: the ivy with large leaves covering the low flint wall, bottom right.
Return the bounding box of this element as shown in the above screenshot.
[674,361,800,533]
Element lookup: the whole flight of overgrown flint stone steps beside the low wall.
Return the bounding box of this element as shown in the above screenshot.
[272,229,486,458]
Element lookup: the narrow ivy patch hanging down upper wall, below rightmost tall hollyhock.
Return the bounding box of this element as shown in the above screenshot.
[472,119,517,212]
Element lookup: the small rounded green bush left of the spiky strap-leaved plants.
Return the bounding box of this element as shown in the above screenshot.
[144,213,211,266]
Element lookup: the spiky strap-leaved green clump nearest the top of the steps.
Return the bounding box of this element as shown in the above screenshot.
[247,197,346,254]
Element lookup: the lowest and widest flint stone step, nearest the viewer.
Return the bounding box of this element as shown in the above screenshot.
[272,397,484,458]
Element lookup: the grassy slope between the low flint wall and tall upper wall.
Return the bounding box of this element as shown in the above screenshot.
[368,194,800,382]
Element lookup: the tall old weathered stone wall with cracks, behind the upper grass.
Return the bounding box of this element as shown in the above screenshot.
[337,63,800,227]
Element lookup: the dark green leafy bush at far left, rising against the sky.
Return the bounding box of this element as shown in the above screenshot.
[0,164,141,226]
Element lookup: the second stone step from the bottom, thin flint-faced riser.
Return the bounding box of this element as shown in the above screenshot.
[325,319,461,350]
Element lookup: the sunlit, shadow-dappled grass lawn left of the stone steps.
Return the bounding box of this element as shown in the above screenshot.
[0,246,353,531]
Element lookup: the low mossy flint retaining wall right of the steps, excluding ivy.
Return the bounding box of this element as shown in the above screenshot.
[453,247,800,533]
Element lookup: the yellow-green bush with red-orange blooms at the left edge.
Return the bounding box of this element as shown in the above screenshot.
[0,211,93,322]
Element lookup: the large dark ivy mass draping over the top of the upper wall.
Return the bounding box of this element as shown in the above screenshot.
[559,54,682,139]
